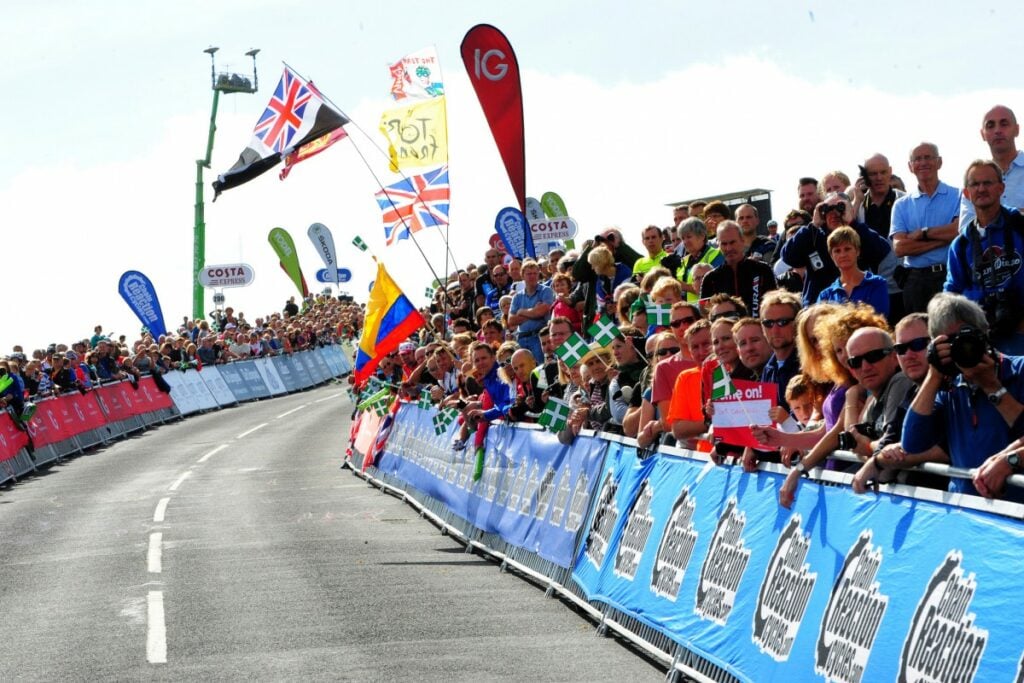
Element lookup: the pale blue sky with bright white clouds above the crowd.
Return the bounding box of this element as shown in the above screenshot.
[0,0,1024,354]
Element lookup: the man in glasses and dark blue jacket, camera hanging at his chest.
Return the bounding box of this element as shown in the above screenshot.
[943,159,1024,355]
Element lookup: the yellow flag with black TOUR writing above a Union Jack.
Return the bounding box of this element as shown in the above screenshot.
[380,96,447,172]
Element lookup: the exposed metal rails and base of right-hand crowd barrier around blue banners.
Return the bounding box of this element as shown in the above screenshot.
[344,409,1024,683]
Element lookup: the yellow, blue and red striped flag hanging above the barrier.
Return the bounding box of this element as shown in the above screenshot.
[355,263,426,384]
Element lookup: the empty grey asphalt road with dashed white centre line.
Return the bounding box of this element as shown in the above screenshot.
[0,385,663,681]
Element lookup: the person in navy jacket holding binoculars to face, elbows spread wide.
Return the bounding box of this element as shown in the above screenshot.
[780,193,902,306]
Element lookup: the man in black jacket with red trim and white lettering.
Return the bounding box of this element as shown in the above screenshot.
[700,220,775,316]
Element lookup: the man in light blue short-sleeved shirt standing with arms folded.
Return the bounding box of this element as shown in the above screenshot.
[890,142,959,313]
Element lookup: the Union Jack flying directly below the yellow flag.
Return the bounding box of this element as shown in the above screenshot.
[376,164,449,245]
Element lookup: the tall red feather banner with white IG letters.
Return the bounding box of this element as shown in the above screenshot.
[461,24,526,213]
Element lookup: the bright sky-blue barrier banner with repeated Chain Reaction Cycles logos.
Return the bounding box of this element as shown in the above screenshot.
[573,446,1024,683]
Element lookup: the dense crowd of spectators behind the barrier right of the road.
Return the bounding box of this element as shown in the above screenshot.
[378,102,1024,506]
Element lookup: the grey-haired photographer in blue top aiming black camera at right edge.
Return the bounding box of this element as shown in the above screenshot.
[903,292,1024,501]
